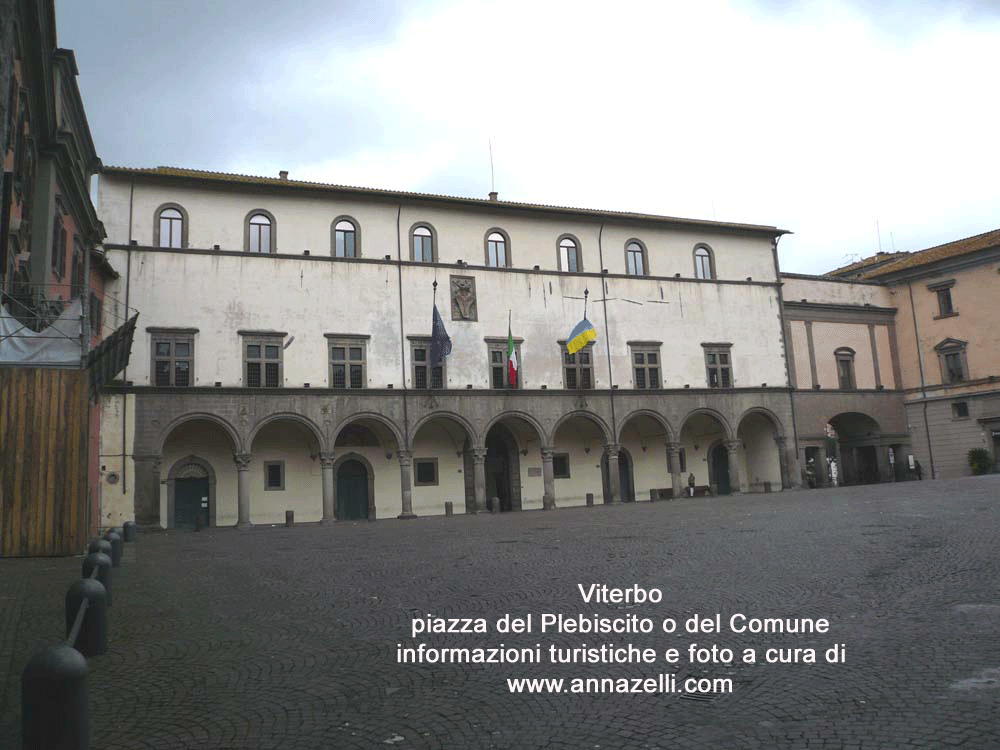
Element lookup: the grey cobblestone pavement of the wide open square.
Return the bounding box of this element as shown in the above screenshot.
[0,476,1000,750]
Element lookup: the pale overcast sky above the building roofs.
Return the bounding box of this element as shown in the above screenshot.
[57,0,1000,273]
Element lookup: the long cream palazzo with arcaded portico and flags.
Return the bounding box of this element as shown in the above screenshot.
[99,167,804,527]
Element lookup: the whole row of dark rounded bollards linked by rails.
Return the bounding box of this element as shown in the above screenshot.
[21,521,137,750]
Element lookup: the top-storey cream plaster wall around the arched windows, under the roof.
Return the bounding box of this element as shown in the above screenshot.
[99,174,776,281]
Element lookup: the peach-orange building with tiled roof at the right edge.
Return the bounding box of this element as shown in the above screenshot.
[831,230,1000,479]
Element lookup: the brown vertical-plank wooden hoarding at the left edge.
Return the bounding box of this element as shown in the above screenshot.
[0,367,90,557]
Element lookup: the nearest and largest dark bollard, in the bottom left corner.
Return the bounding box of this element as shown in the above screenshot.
[21,643,90,750]
